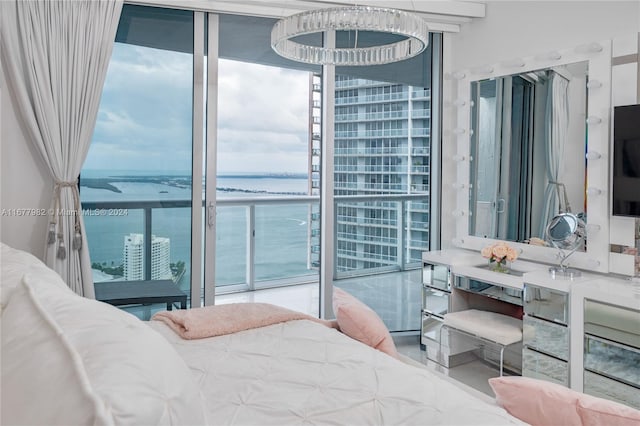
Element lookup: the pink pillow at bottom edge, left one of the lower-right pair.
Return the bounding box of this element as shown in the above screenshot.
[489,376,584,426]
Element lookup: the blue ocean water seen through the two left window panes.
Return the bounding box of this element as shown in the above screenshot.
[80,170,316,293]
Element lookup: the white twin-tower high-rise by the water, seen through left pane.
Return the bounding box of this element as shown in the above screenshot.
[123,233,171,281]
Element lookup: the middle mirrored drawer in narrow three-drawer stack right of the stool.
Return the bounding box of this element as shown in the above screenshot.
[522,315,569,361]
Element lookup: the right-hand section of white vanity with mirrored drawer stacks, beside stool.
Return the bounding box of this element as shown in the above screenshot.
[522,271,640,409]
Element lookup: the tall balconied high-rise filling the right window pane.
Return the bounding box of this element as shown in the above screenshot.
[310,75,431,272]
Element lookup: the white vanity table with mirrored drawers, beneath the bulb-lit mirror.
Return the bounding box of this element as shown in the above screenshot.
[421,249,640,409]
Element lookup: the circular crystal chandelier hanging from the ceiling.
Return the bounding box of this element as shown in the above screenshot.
[271,6,429,66]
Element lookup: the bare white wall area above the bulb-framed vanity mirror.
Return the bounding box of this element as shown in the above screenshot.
[445,1,640,70]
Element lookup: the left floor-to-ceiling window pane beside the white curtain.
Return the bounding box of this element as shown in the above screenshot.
[80,5,193,317]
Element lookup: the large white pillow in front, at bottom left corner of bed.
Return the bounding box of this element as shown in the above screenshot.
[1,274,205,425]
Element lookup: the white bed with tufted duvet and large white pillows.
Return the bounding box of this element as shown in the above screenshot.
[6,244,604,425]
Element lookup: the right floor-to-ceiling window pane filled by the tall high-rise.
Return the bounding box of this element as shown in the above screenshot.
[334,32,439,331]
